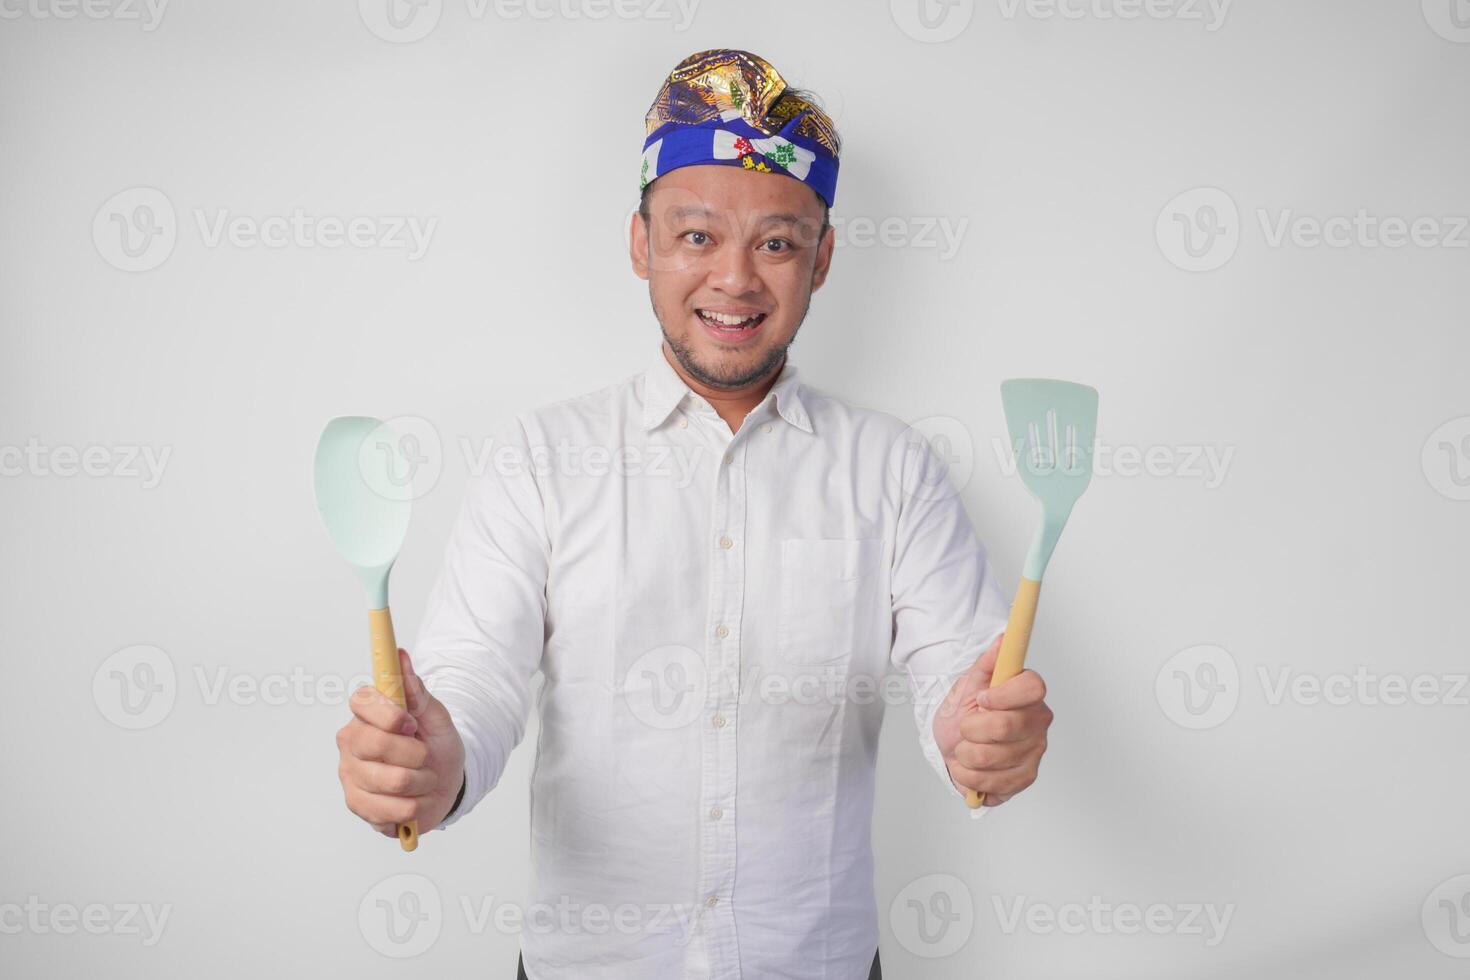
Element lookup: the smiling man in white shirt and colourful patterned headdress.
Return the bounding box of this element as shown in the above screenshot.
[338,50,1051,980]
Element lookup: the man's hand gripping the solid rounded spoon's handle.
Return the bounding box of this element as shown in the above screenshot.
[337,649,465,837]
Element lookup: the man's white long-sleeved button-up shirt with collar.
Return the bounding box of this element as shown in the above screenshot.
[412,348,1008,980]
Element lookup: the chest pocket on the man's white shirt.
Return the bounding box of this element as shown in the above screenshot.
[776,538,882,664]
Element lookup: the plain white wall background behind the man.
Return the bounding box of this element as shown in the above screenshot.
[0,0,1470,980]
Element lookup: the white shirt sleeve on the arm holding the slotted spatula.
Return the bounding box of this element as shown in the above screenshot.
[889,429,1008,820]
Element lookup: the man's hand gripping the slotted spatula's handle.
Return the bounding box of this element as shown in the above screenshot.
[933,636,1051,807]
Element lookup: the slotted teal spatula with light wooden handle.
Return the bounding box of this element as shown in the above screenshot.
[964,378,1098,810]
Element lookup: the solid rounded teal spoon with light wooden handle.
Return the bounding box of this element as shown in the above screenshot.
[313,416,419,851]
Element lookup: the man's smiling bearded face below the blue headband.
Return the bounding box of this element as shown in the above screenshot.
[631,165,833,389]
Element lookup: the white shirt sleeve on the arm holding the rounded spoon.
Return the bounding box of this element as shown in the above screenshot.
[412,422,551,827]
